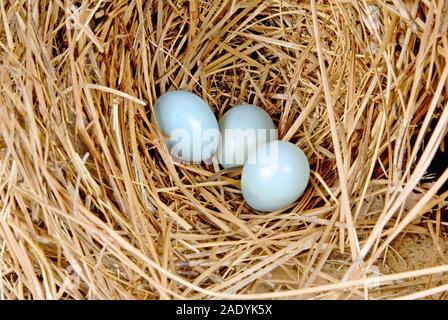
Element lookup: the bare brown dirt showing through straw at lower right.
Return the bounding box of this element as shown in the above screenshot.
[253,233,448,299]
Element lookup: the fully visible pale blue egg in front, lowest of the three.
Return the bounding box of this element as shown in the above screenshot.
[241,141,310,212]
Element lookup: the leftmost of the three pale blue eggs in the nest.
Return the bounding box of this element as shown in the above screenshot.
[154,90,219,163]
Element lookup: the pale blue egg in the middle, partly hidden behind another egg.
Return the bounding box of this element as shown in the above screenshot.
[216,104,277,169]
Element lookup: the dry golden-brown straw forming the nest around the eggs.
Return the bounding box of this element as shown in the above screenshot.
[0,0,448,299]
